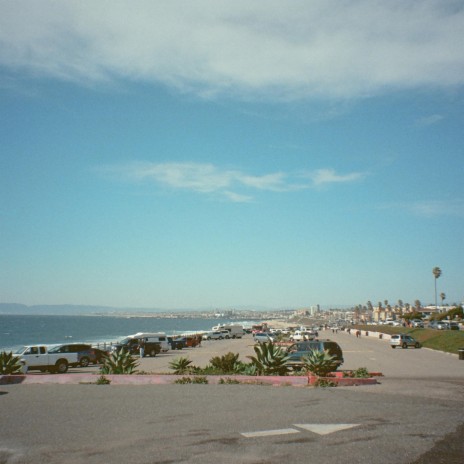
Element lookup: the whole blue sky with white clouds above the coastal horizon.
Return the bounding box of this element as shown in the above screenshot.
[0,0,464,309]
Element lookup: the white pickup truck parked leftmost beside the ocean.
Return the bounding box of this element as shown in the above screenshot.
[15,345,79,374]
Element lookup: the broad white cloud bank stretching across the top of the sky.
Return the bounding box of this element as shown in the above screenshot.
[0,0,464,99]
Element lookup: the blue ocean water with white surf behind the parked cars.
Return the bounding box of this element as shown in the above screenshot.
[0,315,254,351]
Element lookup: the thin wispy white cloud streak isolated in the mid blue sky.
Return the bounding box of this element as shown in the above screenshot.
[105,162,364,202]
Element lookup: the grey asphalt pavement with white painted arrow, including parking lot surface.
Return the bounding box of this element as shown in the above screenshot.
[0,332,464,464]
